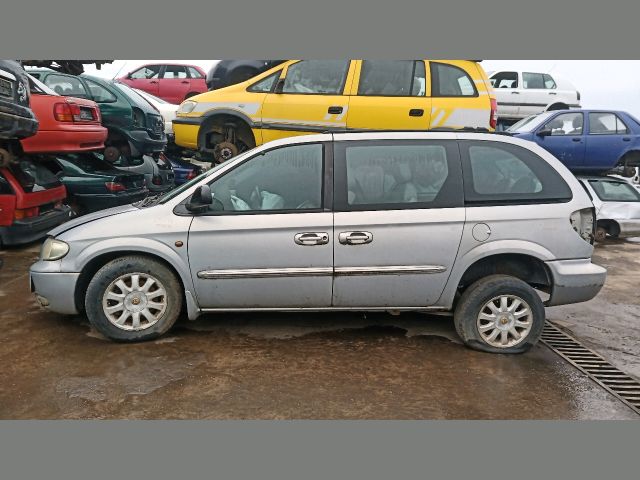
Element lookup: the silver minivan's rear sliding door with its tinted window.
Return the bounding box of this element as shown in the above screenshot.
[333,136,465,308]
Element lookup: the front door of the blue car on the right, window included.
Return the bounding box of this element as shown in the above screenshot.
[534,112,586,168]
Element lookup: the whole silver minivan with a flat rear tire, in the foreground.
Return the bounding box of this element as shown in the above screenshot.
[30,132,606,353]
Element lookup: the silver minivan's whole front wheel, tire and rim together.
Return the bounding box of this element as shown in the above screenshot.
[85,256,182,342]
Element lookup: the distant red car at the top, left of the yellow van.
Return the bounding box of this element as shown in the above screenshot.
[118,63,208,104]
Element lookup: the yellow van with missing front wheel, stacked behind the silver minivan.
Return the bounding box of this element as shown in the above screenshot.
[173,60,497,161]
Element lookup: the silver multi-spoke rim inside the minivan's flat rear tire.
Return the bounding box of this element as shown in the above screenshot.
[476,295,533,348]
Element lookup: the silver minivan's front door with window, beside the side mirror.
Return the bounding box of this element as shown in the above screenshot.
[188,143,333,309]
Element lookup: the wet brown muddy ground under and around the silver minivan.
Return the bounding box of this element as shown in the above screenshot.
[0,241,640,419]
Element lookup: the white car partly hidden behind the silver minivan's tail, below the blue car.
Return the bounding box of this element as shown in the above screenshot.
[579,176,640,242]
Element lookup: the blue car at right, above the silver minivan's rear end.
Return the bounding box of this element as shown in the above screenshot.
[507,110,640,176]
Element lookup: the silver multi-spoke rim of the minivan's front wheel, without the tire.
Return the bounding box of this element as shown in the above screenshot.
[102,273,167,330]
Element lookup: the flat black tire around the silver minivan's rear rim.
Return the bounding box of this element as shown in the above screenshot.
[453,275,545,353]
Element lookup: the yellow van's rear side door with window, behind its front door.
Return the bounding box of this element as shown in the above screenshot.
[347,60,431,130]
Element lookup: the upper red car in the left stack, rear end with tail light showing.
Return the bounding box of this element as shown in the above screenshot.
[21,77,107,153]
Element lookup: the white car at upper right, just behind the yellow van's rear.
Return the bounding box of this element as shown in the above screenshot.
[489,70,580,121]
